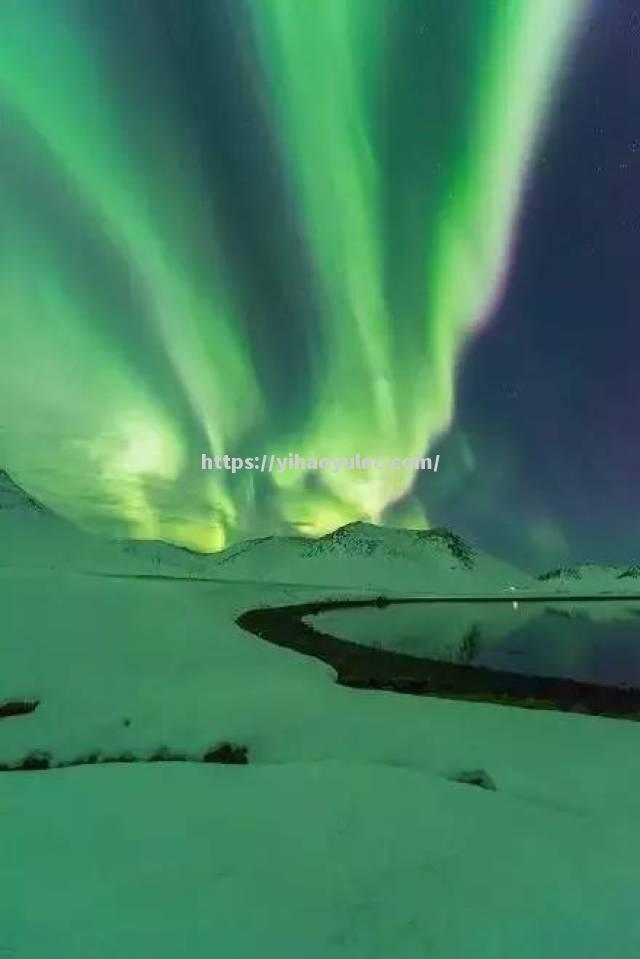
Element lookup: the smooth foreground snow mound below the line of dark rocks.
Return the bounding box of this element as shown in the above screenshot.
[0,762,640,959]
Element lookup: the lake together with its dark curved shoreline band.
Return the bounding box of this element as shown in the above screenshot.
[238,599,640,718]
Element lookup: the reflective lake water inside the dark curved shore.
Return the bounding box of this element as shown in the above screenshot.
[306,600,640,689]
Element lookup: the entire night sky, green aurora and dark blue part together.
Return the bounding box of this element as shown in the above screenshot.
[0,0,640,568]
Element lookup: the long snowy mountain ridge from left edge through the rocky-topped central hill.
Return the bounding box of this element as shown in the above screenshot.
[0,471,535,595]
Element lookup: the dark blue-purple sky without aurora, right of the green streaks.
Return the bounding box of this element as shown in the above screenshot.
[422,0,640,567]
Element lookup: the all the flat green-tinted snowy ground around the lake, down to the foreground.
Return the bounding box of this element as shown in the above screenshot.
[0,474,640,959]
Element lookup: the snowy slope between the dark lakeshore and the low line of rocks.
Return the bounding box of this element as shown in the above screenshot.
[0,571,640,815]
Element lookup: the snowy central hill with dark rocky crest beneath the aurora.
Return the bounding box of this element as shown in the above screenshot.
[216,523,534,595]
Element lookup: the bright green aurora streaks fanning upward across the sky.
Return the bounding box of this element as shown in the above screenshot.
[0,0,616,554]
